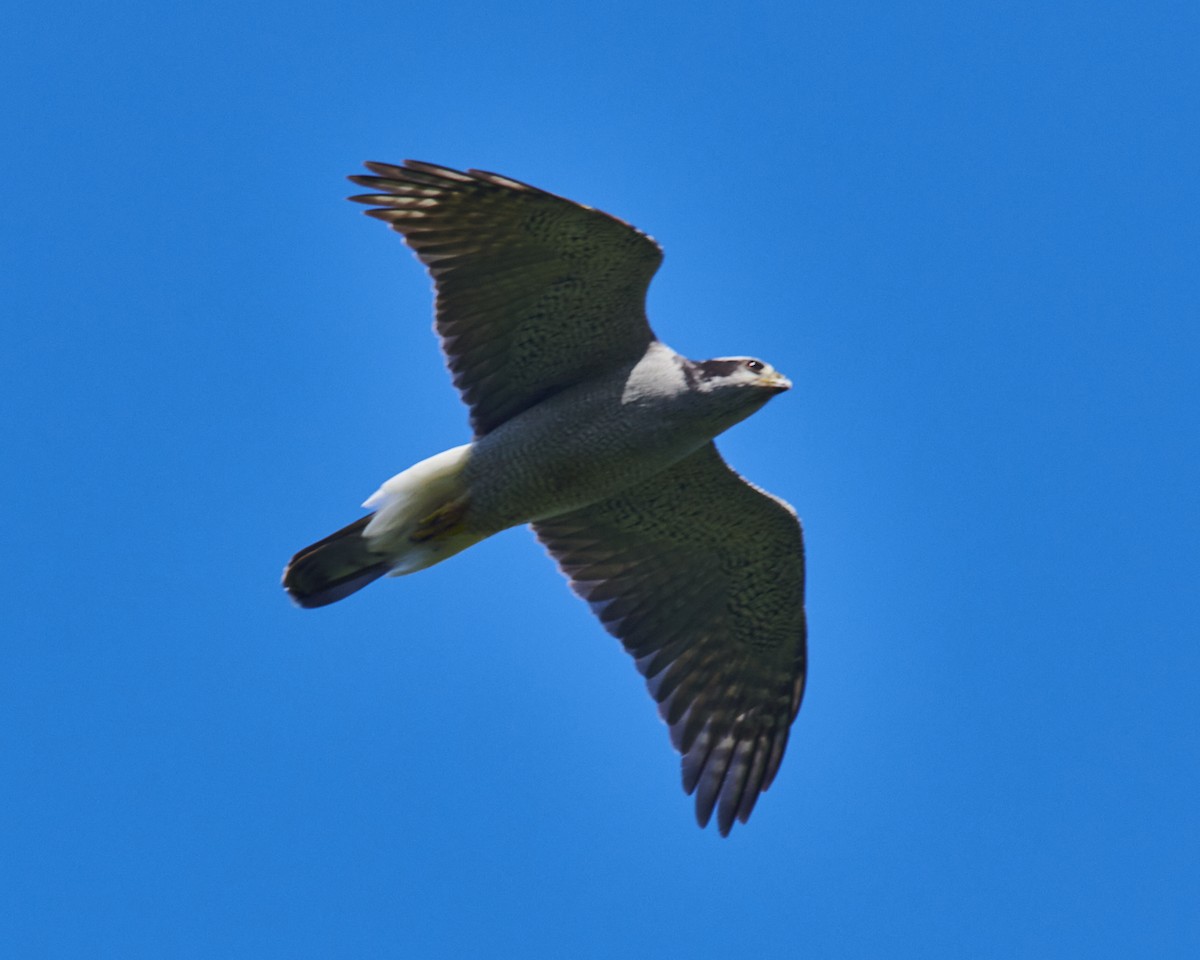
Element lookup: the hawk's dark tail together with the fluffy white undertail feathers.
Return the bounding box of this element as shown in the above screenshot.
[283,444,487,607]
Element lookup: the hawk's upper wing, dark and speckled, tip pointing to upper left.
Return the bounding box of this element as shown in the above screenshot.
[350,160,662,436]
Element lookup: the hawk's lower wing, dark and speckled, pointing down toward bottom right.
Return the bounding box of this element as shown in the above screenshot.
[534,443,805,835]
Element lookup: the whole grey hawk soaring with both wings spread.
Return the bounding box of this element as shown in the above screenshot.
[283,161,806,835]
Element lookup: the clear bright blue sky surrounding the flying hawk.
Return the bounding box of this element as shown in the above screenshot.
[0,0,1200,960]
